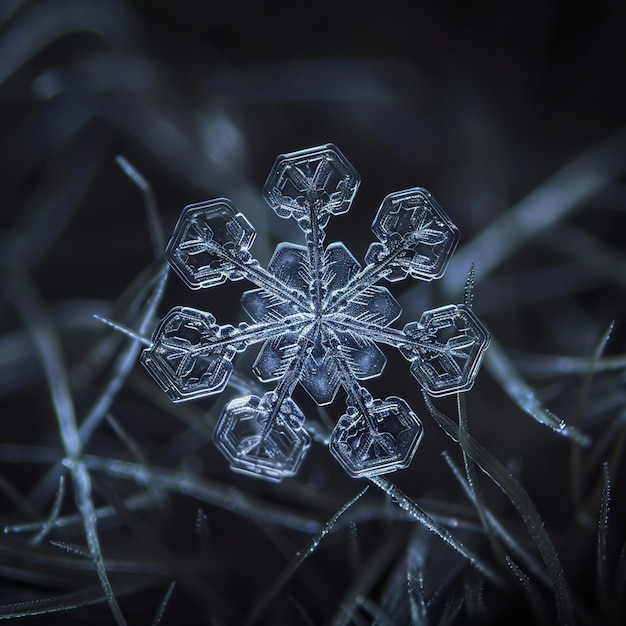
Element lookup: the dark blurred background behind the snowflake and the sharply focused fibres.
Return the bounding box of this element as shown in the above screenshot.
[0,0,626,624]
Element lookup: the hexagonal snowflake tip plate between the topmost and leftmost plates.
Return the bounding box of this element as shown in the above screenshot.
[165,198,256,289]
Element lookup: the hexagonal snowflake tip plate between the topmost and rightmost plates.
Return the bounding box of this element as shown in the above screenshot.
[365,187,459,281]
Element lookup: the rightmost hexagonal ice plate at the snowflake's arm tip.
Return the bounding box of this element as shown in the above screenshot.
[400,304,490,396]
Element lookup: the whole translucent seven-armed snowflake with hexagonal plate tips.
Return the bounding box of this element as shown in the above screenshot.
[141,144,489,480]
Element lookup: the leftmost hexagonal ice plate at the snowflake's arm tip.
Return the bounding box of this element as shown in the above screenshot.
[141,307,234,402]
